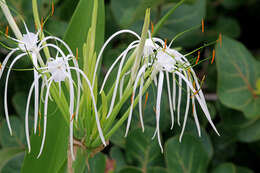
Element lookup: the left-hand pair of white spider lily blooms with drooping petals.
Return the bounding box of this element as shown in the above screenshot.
[0,24,106,160]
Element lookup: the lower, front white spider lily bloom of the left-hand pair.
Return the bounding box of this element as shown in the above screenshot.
[26,53,106,159]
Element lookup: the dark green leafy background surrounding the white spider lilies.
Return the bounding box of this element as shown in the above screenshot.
[0,0,260,173]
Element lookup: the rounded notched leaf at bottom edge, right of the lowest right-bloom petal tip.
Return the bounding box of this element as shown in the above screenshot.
[165,134,209,173]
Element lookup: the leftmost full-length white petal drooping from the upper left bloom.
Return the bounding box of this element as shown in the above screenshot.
[4,53,26,135]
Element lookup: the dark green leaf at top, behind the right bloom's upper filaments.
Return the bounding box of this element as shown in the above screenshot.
[158,0,206,47]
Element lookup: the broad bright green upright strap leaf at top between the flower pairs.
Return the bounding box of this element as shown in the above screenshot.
[64,0,105,67]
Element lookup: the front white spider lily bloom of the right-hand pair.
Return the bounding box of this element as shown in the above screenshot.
[125,38,219,151]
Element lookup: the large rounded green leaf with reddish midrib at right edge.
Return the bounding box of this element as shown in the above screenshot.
[216,37,260,119]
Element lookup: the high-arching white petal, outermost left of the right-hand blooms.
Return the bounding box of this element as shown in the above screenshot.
[92,30,141,87]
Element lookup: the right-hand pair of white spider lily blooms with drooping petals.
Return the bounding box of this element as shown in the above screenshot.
[99,30,219,151]
